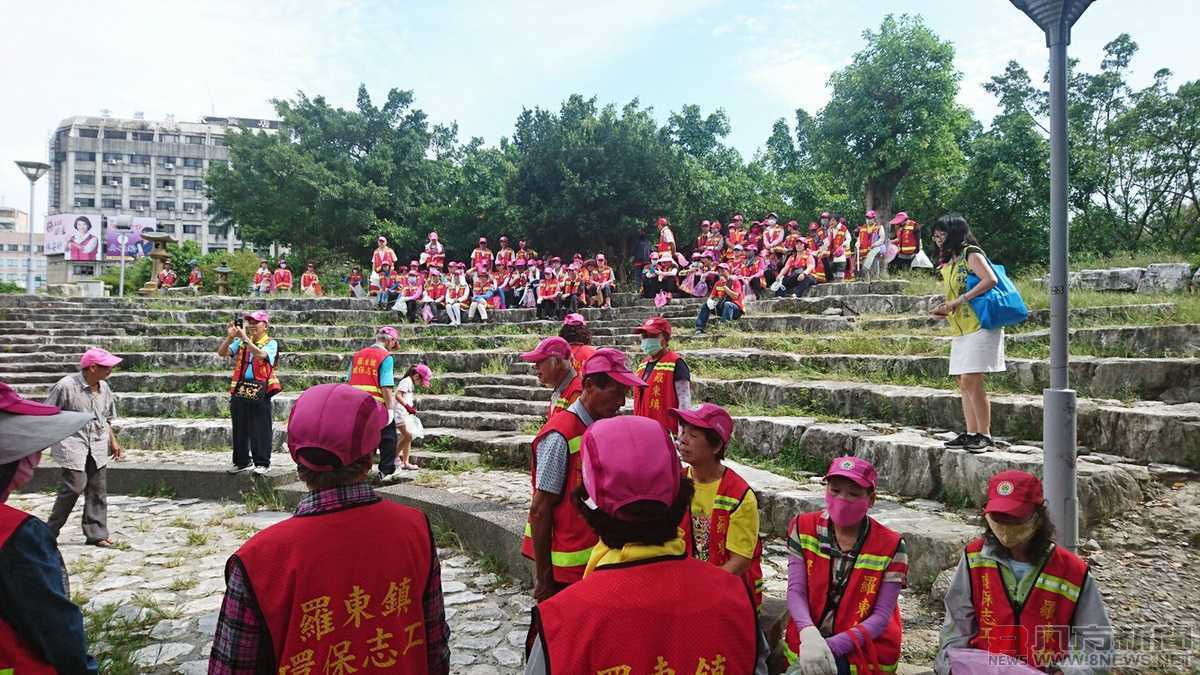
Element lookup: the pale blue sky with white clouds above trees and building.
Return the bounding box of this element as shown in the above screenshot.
[0,0,1200,227]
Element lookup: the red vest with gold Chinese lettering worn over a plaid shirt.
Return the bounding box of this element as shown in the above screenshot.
[235,501,434,674]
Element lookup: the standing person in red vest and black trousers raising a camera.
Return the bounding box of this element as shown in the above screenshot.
[217,310,282,476]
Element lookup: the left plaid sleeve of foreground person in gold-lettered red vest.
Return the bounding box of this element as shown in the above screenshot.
[209,555,275,675]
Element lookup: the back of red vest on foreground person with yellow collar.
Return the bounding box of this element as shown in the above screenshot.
[534,557,758,675]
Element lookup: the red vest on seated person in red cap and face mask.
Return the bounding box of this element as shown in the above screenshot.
[965,538,1087,668]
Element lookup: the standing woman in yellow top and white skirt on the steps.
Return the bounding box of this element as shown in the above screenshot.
[932,214,1006,453]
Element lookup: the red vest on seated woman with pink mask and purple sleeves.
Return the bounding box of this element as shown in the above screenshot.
[784,510,901,674]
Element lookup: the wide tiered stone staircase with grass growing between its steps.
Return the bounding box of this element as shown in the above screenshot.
[0,281,1200,667]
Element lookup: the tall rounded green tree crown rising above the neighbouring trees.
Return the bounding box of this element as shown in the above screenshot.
[817,14,971,224]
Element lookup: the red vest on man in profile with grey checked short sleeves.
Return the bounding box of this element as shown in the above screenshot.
[521,412,599,584]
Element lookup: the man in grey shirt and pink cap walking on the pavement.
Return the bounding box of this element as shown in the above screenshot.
[46,348,124,548]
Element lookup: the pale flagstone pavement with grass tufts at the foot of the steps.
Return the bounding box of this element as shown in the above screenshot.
[8,487,533,675]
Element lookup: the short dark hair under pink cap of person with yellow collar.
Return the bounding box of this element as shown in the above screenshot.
[571,477,696,549]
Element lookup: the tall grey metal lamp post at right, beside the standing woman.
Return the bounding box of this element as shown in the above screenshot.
[1010,0,1093,550]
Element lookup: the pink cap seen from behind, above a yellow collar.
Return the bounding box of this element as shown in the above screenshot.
[582,415,679,515]
